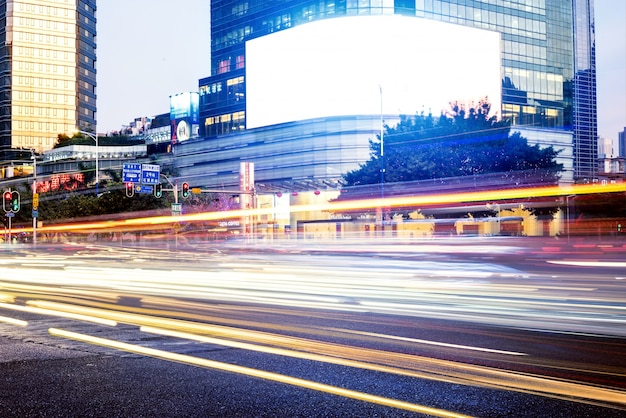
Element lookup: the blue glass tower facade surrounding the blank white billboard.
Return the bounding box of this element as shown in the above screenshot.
[199,0,597,180]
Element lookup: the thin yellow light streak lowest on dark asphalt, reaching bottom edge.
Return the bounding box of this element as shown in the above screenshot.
[49,328,469,418]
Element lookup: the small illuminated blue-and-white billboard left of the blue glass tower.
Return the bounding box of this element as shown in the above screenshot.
[170,93,200,144]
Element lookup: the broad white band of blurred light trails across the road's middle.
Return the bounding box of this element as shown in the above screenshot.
[0,256,626,335]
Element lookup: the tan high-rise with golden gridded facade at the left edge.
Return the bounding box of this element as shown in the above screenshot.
[0,0,96,154]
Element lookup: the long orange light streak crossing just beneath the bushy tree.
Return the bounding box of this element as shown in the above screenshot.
[15,183,626,233]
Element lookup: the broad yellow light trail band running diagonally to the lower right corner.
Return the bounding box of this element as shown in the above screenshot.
[19,301,626,408]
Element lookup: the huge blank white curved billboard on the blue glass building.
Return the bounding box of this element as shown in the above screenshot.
[246,16,501,129]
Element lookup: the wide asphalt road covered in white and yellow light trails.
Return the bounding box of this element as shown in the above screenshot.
[0,241,626,417]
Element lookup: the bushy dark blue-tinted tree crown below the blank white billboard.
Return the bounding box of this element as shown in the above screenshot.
[344,100,563,186]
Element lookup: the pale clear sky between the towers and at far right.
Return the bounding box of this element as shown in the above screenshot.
[97,0,626,139]
